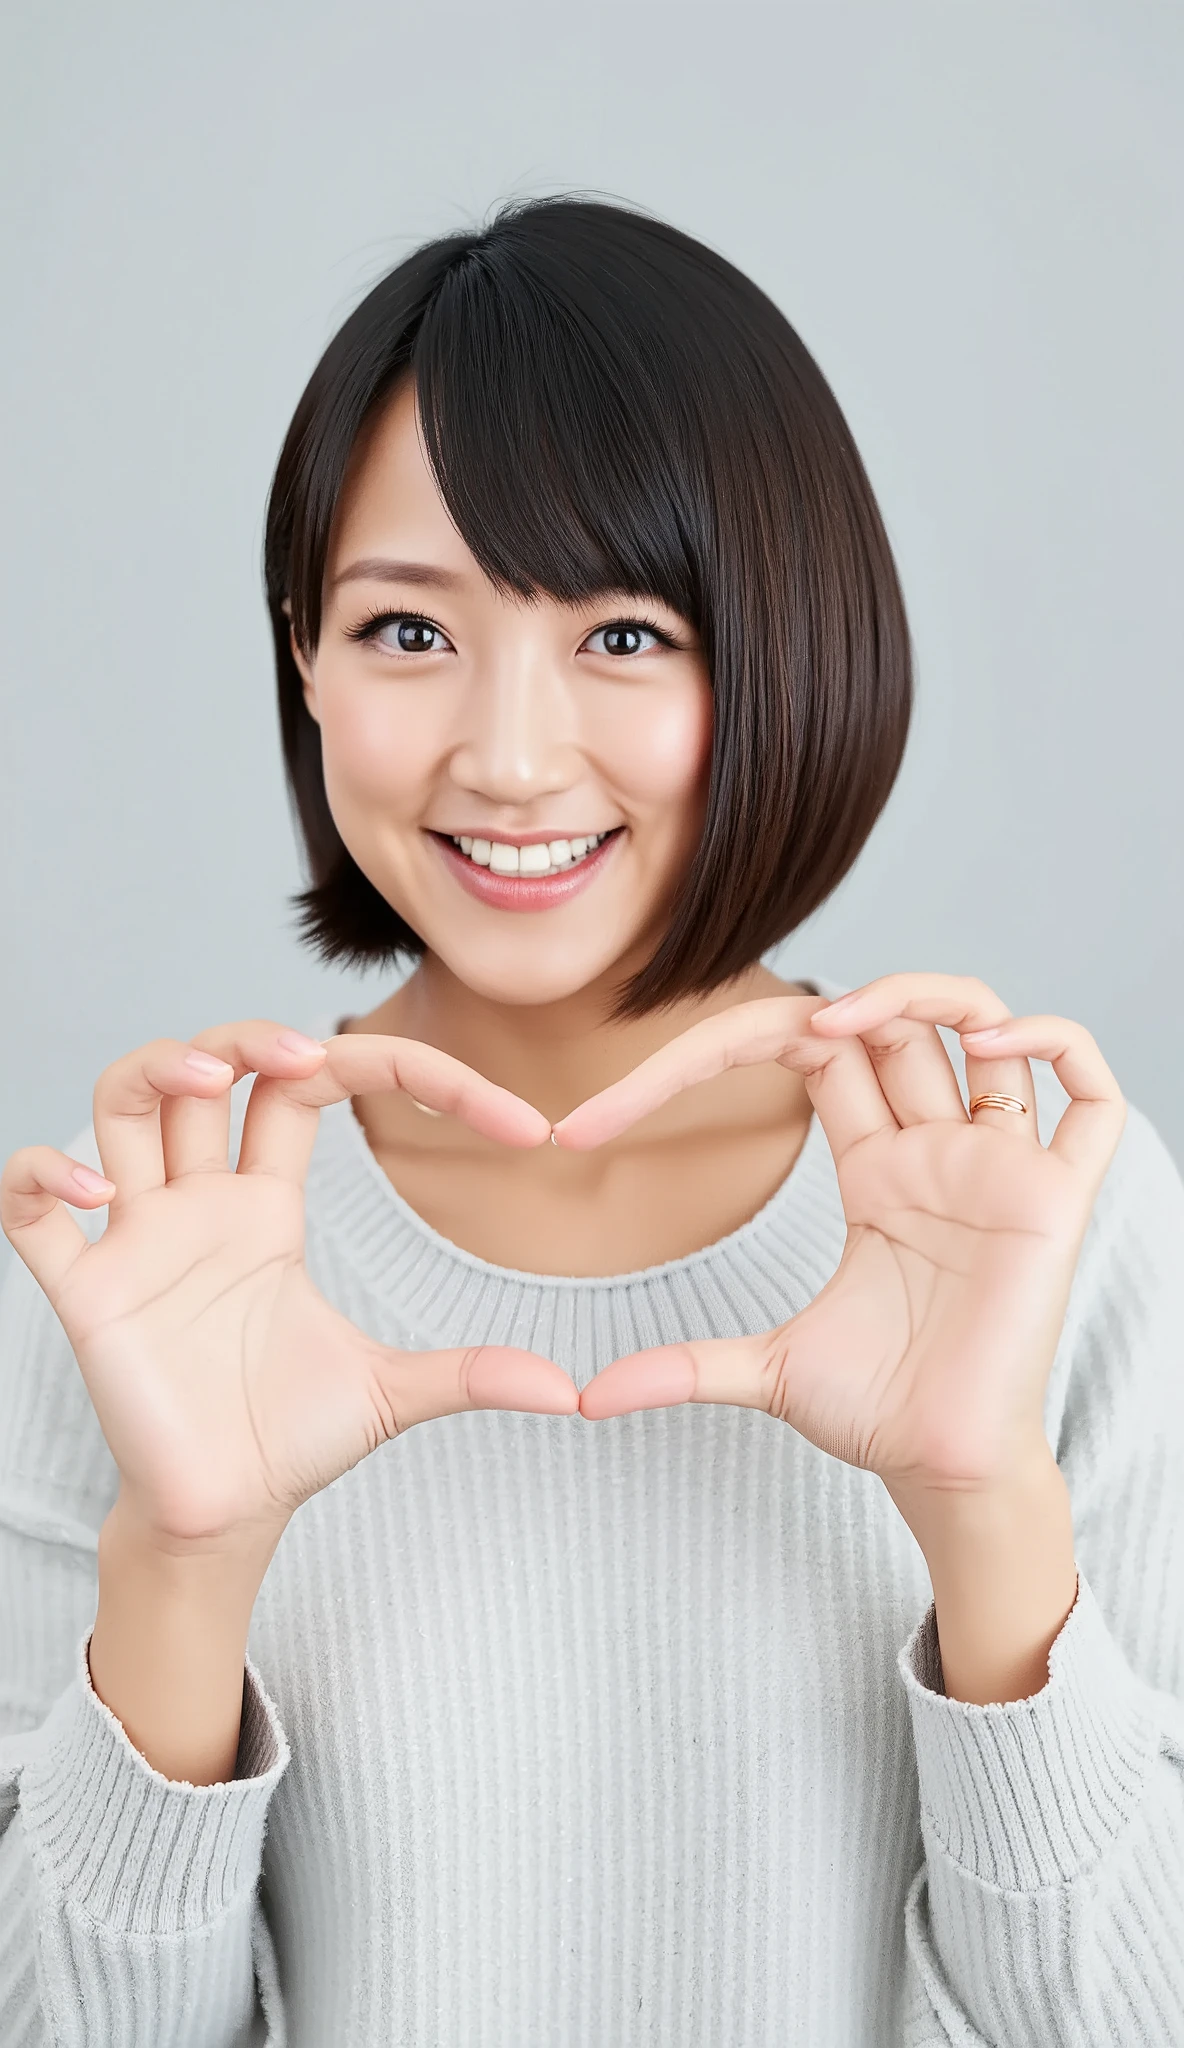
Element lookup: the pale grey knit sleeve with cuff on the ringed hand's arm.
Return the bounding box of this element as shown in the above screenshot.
[899,1106,1184,2048]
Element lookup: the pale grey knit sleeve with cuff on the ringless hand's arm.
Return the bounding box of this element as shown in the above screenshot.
[0,1137,289,2048]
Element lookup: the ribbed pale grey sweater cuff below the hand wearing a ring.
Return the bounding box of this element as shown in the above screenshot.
[897,1567,1161,1890]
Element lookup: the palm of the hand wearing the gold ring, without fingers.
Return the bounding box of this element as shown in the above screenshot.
[774,1124,1080,1483]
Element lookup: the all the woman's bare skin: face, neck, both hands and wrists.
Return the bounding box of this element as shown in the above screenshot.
[0,387,1125,1784]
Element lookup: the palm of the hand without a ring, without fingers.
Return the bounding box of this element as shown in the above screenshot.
[55,1171,391,1538]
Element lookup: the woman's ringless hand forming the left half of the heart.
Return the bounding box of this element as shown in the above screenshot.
[0,1020,580,1550]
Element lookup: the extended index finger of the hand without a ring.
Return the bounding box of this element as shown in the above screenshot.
[238,1032,551,1184]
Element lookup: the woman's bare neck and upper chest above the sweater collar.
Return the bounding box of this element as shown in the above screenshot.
[337,958,811,1276]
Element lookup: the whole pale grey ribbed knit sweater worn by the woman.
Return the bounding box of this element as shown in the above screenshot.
[0,981,1184,2048]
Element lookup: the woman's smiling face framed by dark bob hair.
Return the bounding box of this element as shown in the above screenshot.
[295,383,711,1004]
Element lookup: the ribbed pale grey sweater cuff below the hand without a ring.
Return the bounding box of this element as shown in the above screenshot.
[20,1624,291,1935]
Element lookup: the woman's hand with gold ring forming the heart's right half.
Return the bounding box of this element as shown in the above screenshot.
[555,975,1127,1495]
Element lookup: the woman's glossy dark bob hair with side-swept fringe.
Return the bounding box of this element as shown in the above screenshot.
[264,197,912,1016]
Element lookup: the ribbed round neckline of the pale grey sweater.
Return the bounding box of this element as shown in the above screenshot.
[299,975,846,1309]
